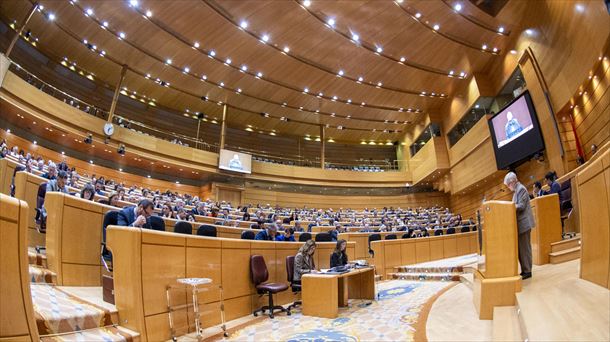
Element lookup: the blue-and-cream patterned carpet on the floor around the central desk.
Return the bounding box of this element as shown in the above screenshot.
[223,280,455,342]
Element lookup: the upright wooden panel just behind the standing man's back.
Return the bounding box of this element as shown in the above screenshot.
[530,194,561,265]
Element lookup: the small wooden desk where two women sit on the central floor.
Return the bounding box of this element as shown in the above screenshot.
[301,267,375,318]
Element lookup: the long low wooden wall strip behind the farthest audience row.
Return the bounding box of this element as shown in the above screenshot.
[242,188,448,209]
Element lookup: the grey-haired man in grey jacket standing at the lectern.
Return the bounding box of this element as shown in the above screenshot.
[504,172,534,279]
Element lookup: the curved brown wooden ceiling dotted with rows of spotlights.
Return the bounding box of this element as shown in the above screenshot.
[0,0,525,141]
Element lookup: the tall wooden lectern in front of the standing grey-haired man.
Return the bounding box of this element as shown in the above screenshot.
[473,201,521,319]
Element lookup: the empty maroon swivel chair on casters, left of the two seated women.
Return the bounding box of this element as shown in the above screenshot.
[250,255,290,318]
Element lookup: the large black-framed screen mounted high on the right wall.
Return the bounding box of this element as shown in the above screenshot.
[489,91,544,170]
